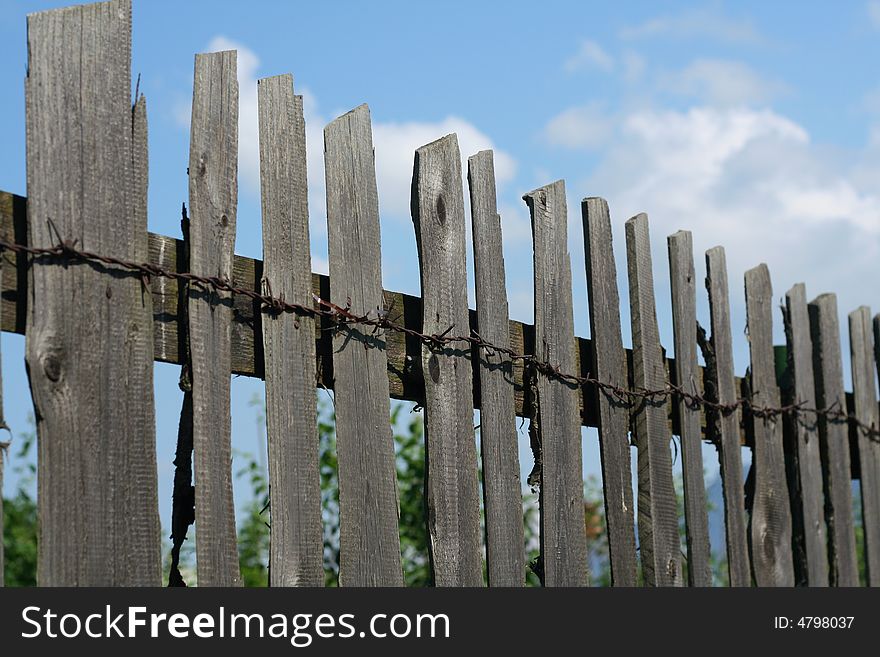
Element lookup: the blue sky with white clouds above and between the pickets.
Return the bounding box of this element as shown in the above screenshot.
[0,0,880,552]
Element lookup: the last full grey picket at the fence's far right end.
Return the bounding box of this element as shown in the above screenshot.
[849,306,880,586]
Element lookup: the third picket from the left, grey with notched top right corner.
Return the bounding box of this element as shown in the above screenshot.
[260,75,324,586]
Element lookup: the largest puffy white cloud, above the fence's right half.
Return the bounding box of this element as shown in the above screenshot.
[583,107,880,339]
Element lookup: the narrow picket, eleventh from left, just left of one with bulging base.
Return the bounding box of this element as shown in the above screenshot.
[706,246,752,586]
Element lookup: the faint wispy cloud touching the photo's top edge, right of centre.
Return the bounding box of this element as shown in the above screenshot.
[620,7,761,43]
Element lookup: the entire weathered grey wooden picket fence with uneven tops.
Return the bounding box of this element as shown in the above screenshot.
[0,0,880,586]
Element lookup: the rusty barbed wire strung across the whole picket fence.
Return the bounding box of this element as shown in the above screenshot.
[0,227,880,440]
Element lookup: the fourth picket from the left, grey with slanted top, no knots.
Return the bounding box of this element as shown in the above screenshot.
[324,105,404,586]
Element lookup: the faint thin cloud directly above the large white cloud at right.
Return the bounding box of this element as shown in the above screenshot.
[658,59,785,105]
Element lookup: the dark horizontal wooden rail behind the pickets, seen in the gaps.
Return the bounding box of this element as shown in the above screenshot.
[0,191,853,445]
